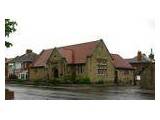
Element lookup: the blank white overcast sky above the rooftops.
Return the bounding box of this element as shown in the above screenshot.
[5,0,158,58]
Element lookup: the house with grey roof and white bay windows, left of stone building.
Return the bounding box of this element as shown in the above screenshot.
[6,49,37,80]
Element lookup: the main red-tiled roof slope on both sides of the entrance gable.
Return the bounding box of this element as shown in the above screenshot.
[33,40,99,67]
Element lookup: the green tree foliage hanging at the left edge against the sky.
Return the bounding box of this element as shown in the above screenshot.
[5,19,17,48]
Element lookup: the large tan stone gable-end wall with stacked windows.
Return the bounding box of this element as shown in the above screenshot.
[86,42,115,83]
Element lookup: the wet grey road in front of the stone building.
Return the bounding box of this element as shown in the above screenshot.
[6,84,155,100]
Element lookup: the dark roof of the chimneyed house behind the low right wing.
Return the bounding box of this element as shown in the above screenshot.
[126,54,151,63]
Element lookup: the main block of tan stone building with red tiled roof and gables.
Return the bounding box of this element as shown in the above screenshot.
[30,40,115,82]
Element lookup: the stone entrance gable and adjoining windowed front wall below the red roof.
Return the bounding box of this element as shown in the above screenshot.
[47,49,86,80]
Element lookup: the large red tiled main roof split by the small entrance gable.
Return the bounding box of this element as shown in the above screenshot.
[34,40,102,66]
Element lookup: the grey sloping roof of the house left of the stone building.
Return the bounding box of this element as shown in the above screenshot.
[10,52,37,62]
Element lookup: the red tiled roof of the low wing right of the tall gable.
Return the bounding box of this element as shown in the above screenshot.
[111,54,133,69]
